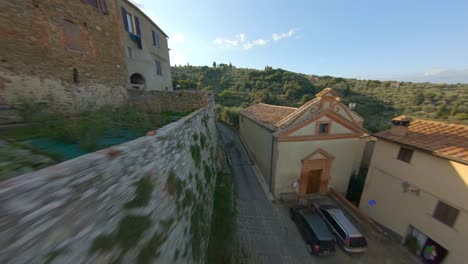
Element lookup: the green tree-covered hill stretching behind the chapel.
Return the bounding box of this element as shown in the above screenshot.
[172,64,468,132]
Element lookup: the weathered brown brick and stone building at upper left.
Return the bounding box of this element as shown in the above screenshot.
[0,0,126,119]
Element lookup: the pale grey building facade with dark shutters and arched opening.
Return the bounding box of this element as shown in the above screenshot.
[118,0,173,91]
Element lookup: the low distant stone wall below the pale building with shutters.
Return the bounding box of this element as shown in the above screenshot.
[128,90,211,113]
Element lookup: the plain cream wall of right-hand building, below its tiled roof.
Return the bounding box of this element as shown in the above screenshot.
[360,139,468,263]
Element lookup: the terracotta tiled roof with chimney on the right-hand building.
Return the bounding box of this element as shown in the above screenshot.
[374,119,468,164]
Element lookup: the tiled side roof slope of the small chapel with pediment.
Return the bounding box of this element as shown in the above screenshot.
[240,104,297,130]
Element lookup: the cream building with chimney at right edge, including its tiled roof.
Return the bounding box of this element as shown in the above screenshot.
[359,116,468,263]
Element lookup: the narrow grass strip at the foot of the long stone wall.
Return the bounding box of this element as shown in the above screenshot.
[206,173,236,263]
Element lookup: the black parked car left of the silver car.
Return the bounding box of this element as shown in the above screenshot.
[290,205,335,255]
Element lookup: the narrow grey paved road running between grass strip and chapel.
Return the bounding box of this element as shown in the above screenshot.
[219,124,314,264]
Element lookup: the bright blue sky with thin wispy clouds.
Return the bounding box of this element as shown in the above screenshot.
[132,0,468,83]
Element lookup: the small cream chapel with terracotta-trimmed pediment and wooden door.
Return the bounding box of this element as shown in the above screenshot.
[239,88,367,197]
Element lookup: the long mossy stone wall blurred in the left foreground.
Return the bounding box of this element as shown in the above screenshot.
[0,103,218,263]
